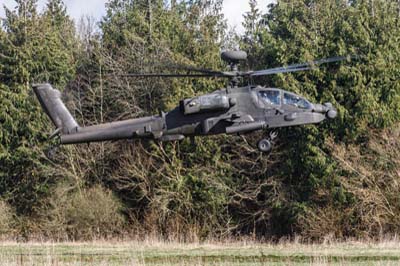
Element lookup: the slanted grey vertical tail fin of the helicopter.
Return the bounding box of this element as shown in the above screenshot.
[33,84,79,134]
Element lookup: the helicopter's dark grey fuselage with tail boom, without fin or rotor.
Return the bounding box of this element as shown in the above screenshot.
[61,86,336,144]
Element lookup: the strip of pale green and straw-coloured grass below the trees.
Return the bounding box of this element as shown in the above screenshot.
[0,241,400,266]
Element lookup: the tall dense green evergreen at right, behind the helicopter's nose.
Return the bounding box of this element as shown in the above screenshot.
[238,0,400,237]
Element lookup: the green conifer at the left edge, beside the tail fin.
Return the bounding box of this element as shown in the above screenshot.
[0,0,74,215]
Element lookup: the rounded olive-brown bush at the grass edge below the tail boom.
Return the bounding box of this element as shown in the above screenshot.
[50,185,124,240]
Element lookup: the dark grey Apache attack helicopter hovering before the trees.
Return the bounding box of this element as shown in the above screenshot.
[33,51,347,152]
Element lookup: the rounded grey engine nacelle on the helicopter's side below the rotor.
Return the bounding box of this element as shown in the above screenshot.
[180,93,230,115]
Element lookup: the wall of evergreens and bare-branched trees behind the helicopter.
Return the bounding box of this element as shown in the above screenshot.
[0,0,400,241]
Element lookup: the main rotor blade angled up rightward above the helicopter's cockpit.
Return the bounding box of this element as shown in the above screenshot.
[250,56,348,77]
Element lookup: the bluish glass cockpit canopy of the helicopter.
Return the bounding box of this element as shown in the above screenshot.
[258,89,311,109]
